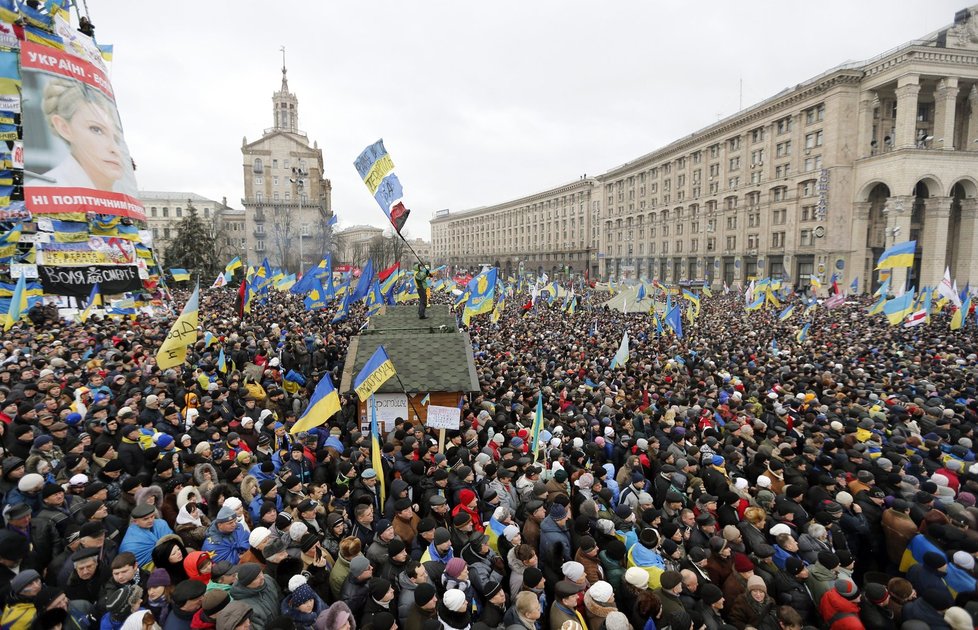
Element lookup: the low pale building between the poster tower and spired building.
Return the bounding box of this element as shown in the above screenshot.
[139,190,247,270]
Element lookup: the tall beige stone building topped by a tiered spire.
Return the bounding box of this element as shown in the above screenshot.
[241,48,332,272]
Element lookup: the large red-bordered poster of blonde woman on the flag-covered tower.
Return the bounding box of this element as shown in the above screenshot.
[21,42,145,220]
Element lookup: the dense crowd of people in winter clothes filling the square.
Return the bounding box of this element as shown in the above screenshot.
[0,289,978,630]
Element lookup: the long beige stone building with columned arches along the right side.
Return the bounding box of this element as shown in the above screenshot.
[431,7,978,290]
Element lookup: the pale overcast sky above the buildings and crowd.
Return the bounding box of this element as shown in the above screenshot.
[88,0,967,238]
